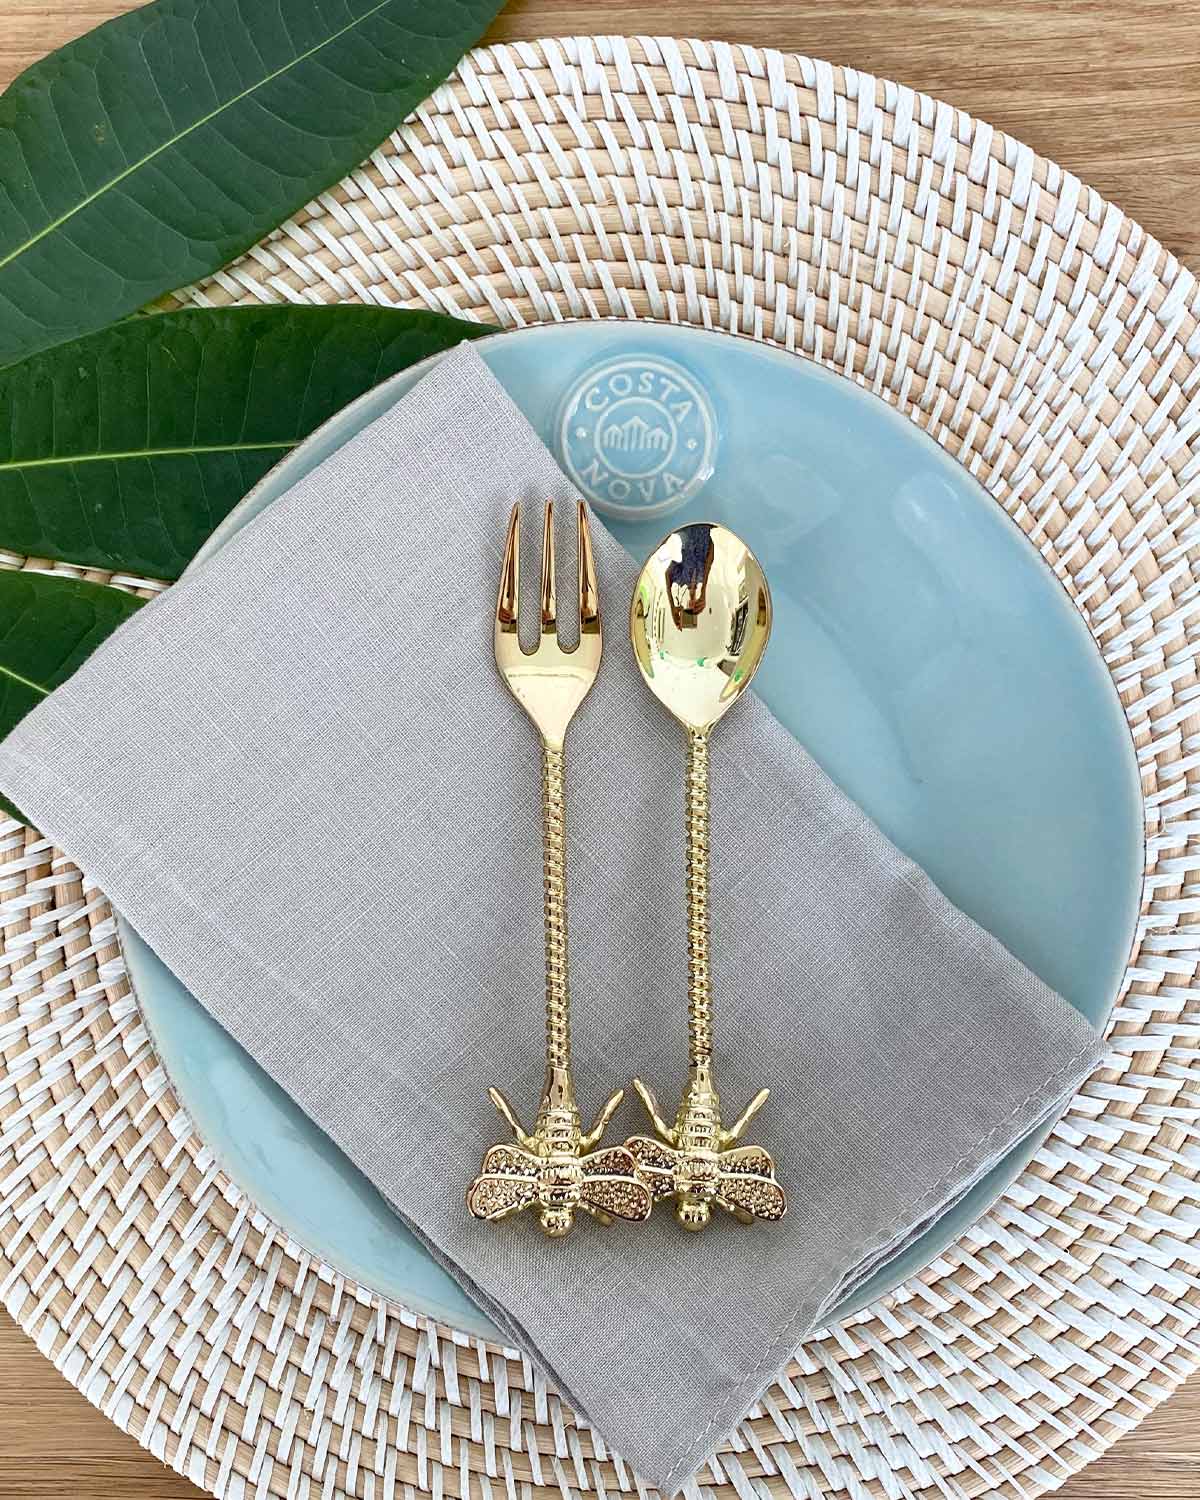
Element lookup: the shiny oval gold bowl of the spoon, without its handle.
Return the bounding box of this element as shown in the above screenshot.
[630,522,771,734]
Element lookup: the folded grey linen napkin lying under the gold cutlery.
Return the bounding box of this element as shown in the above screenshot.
[0,345,1100,1491]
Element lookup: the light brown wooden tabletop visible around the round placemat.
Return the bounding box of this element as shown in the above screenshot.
[0,0,1200,1500]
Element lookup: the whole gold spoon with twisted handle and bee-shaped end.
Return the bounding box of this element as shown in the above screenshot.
[627,524,788,1230]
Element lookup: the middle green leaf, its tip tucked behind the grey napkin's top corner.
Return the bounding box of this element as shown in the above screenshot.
[0,306,492,579]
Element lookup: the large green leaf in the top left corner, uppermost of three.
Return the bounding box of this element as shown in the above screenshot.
[0,0,503,365]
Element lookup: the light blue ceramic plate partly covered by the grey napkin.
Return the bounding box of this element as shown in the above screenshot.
[125,323,1143,1334]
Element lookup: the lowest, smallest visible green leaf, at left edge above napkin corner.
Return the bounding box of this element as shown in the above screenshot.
[0,569,143,822]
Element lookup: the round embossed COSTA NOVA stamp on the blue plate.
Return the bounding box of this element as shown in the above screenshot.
[560,356,717,521]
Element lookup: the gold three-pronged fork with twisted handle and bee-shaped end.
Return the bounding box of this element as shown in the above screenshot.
[467,503,653,1238]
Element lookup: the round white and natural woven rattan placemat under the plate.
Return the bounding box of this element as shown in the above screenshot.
[0,39,1200,1500]
